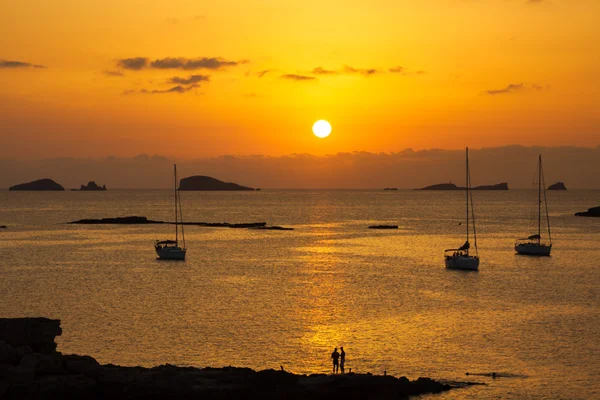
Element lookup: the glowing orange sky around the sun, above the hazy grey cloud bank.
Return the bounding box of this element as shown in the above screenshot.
[0,0,600,158]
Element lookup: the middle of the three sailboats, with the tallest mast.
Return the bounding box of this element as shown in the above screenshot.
[444,147,479,271]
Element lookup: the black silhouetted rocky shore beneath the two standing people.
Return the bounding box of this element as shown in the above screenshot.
[0,318,468,400]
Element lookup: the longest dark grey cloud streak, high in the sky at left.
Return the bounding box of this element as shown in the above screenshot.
[117,57,249,71]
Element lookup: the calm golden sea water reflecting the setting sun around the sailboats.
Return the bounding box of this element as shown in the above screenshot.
[0,190,600,399]
